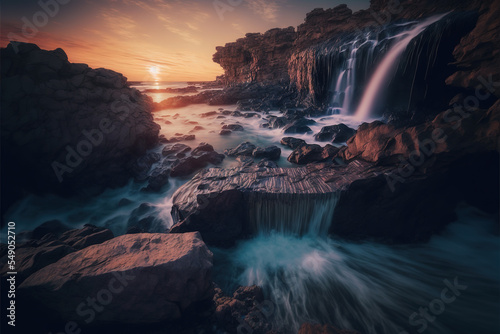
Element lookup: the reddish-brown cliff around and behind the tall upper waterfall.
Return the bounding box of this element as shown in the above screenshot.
[213,0,500,115]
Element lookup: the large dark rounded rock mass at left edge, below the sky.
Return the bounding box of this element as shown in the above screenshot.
[0,42,160,206]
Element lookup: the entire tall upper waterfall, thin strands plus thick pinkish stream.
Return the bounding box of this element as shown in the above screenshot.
[310,14,456,120]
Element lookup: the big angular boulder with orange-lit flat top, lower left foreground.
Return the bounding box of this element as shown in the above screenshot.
[18,233,212,326]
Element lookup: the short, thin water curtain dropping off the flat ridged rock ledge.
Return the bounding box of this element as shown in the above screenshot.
[248,193,337,236]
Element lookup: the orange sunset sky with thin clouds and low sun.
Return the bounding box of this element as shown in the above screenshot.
[0,0,369,81]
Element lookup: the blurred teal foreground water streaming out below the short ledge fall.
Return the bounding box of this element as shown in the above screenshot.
[212,206,500,334]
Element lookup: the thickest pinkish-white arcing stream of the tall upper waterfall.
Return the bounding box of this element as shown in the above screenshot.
[355,14,447,120]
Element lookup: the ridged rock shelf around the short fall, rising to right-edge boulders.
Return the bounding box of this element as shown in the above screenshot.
[172,105,500,244]
